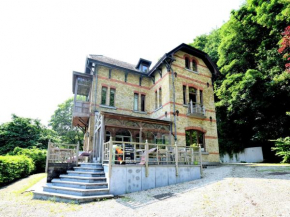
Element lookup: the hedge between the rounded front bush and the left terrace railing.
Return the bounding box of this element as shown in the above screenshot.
[12,147,46,173]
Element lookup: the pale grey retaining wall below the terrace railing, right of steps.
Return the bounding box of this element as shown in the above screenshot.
[104,165,200,195]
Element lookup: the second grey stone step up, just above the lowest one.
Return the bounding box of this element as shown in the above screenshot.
[43,185,109,196]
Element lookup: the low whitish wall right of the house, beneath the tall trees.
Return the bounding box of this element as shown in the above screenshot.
[220,147,264,163]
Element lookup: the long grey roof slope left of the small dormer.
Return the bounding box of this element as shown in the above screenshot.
[88,54,140,72]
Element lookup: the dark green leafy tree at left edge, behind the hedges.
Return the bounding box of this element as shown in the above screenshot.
[0,114,58,155]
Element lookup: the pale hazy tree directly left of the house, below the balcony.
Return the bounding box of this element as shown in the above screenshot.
[49,98,84,144]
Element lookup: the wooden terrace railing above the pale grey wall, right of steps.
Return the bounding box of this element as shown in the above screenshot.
[102,137,202,176]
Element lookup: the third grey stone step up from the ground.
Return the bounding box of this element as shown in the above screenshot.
[51,179,108,189]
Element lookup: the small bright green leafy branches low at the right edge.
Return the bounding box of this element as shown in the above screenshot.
[272,137,290,163]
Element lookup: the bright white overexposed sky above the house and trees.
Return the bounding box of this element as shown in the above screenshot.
[0,0,244,125]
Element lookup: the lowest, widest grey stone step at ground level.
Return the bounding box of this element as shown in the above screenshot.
[33,191,114,203]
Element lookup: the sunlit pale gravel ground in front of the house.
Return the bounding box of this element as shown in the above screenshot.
[0,164,290,217]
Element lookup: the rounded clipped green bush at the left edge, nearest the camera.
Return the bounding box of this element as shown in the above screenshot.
[0,155,34,186]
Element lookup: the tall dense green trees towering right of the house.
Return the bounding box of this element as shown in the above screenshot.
[191,0,290,158]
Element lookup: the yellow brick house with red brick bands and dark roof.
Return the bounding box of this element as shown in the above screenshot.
[73,44,220,163]
